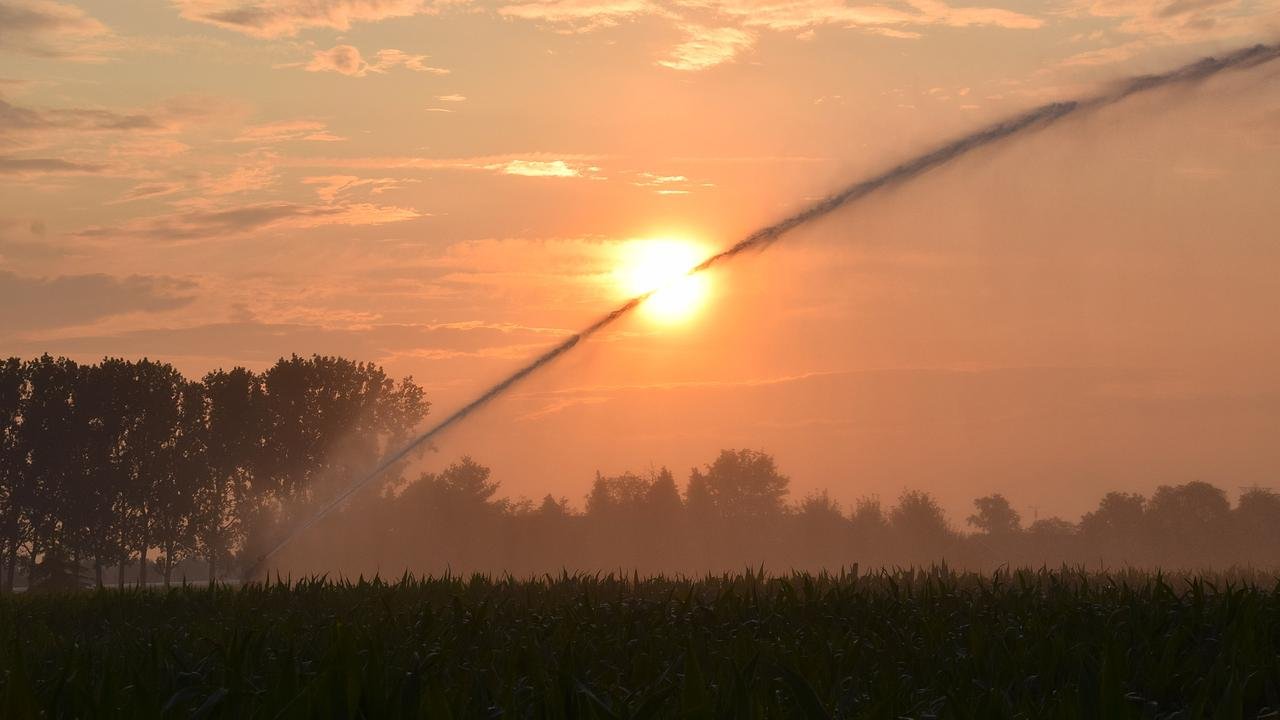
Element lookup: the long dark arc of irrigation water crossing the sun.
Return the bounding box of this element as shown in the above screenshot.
[247,45,1280,578]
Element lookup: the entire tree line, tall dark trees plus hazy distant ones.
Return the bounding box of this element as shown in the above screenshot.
[0,355,1280,589]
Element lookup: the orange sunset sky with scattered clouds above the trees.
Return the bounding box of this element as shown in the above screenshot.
[0,0,1280,524]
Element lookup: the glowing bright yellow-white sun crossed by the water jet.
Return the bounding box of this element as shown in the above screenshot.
[614,238,708,323]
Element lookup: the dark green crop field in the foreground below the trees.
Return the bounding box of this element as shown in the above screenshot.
[0,570,1280,719]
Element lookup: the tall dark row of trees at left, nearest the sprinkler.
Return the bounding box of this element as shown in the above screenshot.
[0,355,429,591]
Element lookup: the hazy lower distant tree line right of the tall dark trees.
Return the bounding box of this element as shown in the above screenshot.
[290,450,1280,577]
